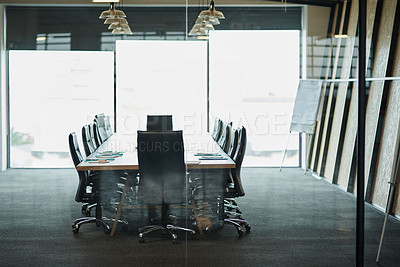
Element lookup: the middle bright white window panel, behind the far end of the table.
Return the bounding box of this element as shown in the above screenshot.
[116,41,207,134]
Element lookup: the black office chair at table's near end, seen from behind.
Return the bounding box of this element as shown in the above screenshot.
[137,131,195,244]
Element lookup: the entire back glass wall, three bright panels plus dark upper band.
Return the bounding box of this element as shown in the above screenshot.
[6,4,302,167]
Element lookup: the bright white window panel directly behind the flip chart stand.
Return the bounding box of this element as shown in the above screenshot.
[209,31,300,166]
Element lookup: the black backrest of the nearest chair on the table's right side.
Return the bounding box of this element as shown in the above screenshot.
[231,127,247,197]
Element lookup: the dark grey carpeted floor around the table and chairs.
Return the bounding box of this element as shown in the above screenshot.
[0,168,400,266]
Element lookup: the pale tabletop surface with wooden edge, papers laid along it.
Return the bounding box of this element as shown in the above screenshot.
[76,134,236,171]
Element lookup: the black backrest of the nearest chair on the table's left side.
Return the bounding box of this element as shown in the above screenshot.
[68,132,88,202]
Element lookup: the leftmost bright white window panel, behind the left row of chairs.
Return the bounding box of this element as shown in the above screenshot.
[9,51,114,168]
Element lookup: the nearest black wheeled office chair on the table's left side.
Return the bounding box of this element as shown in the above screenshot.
[68,132,111,234]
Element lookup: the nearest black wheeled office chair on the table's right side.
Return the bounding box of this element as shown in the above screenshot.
[224,127,251,236]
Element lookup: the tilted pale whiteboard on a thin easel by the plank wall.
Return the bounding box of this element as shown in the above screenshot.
[290,80,322,134]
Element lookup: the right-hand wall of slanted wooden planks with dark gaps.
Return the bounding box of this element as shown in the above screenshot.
[308,0,400,218]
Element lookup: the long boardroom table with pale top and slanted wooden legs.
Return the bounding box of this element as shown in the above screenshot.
[76,134,236,236]
